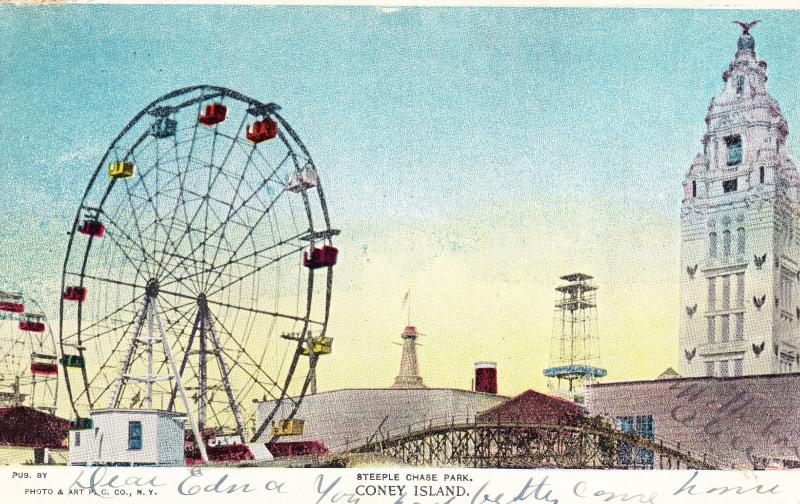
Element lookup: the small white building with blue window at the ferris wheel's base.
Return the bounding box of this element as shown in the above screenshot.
[69,409,185,466]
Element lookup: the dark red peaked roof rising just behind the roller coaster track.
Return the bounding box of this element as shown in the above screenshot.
[478,390,586,424]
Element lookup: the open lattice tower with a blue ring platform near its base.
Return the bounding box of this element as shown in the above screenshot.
[544,273,606,404]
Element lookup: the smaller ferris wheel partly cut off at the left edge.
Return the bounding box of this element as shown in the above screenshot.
[0,291,58,415]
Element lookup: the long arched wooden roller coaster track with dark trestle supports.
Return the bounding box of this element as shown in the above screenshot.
[347,418,728,469]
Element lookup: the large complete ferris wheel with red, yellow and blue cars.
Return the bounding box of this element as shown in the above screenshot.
[60,86,338,456]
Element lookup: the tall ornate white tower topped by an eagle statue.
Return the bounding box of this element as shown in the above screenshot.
[680,22,800,376]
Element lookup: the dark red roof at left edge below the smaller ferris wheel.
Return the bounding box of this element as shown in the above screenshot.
[0,406,69,448]
